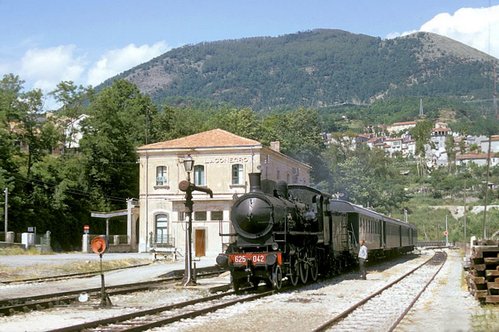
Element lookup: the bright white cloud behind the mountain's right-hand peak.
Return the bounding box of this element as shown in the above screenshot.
[394,5,499,58]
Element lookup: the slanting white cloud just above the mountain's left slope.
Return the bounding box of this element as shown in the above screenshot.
[87,41,169,85]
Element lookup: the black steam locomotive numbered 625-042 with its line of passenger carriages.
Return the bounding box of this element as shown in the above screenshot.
[216,173,417,291]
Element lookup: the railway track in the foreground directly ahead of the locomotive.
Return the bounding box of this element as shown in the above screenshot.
[52,291,275,332]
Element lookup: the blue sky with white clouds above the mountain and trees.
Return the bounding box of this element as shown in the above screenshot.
[0,0,499,103]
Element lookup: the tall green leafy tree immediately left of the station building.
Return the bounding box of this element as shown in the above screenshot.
[80,80,156,210]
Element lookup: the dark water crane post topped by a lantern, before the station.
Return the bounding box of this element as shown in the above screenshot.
[178,155,213,287]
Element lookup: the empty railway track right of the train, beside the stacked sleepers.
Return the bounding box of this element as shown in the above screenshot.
[314,251,447,331]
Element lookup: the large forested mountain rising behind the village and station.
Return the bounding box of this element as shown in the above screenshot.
[103,29,497,110]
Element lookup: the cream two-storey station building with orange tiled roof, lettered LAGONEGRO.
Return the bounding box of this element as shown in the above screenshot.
[136,129,311,257]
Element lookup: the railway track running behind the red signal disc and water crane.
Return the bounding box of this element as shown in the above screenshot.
[0,268,225,316]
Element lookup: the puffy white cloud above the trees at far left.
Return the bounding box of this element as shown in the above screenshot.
[19,45,85,92]
